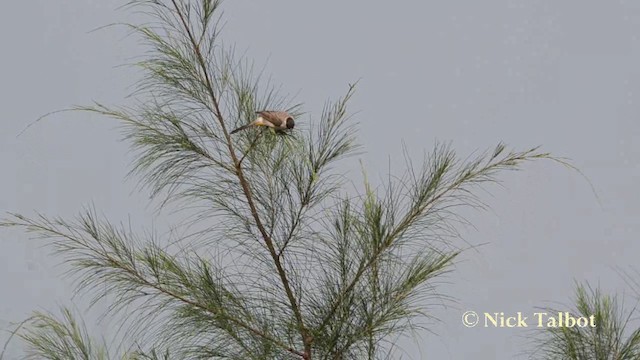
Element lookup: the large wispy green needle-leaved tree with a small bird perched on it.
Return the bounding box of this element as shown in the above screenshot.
[2,0,552,359]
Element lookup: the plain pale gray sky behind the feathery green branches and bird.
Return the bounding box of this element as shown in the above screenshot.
[0,0,640,359]
